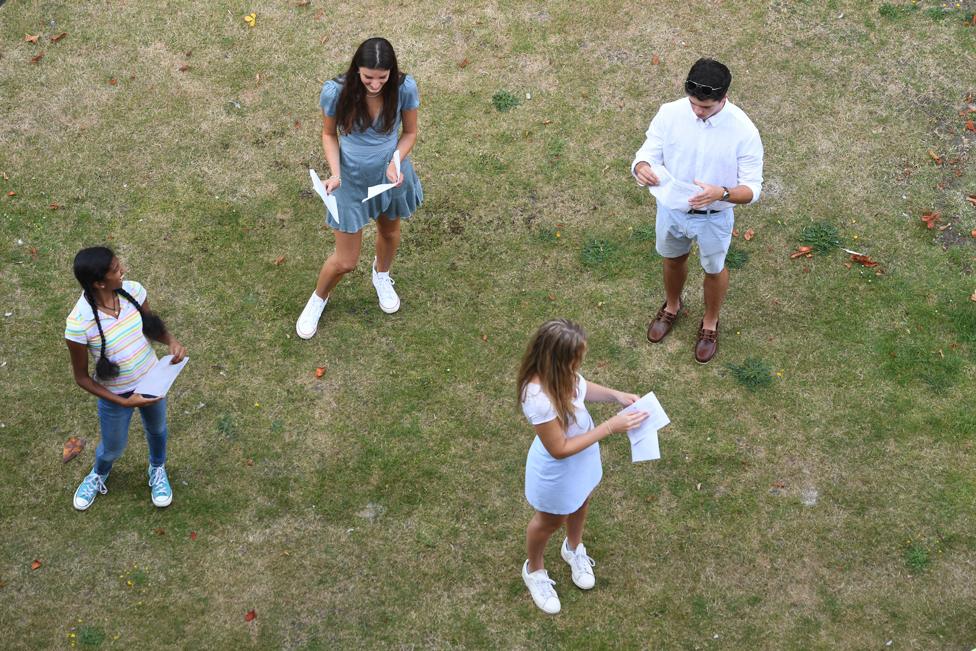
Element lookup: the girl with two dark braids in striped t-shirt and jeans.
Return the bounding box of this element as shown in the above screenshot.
[64,246,186,511]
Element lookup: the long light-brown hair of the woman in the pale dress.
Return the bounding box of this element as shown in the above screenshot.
[516,319,586,429]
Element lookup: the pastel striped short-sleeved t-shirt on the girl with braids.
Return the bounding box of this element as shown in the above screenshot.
[64,280,156,393]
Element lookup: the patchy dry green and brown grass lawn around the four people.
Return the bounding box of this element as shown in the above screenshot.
[0,0,976,649]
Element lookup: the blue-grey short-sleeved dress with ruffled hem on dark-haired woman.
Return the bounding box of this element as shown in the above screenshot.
[319,75,424,233]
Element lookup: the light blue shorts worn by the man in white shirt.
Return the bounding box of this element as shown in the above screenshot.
[654,205,735,274]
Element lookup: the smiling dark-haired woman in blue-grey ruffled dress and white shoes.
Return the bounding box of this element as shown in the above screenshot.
[295,38,423,339]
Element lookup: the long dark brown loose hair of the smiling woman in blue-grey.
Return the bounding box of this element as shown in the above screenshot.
[336,37,406,133]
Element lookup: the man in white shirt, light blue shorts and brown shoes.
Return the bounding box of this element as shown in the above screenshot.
[631,59,763,364]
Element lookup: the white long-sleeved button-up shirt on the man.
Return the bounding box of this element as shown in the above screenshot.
[630,97,763,210]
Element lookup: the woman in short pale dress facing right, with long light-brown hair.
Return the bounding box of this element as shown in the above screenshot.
[516,319,648,615]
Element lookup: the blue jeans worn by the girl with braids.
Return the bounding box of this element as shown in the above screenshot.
[95,394,167,475]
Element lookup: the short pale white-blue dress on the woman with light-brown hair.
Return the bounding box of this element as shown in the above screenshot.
[522,374,603,515]
